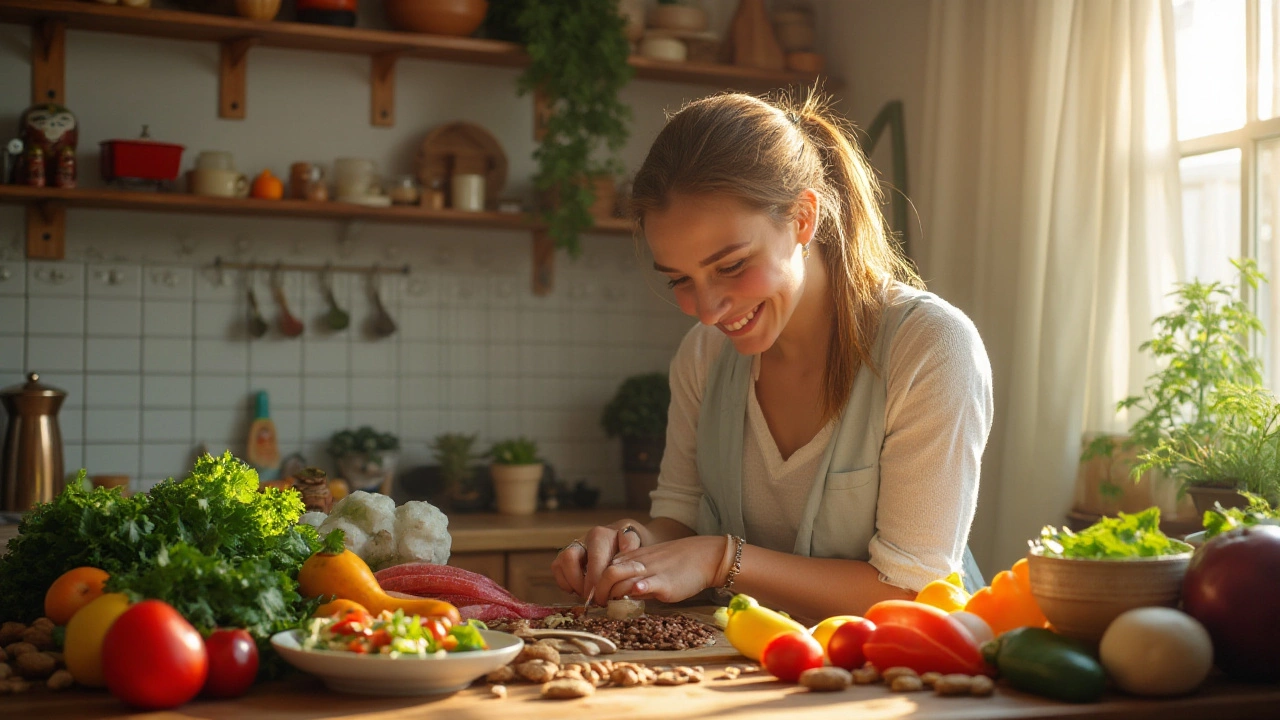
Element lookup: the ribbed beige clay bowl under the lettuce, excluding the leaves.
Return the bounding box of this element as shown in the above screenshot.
[1027,548,1192,643]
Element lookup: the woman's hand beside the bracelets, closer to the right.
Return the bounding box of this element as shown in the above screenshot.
[595,536,724,602]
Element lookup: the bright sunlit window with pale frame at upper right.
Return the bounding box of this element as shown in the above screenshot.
[1174,0,1280,388]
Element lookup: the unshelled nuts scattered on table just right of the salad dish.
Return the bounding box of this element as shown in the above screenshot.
[485,641,736,700]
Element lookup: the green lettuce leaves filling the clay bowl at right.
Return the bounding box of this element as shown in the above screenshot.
[1030,507,1192,560]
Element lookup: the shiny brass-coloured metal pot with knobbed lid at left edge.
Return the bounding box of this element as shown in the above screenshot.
[0,373,67,511]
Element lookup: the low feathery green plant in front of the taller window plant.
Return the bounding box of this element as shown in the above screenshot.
[1134,383,1280,515]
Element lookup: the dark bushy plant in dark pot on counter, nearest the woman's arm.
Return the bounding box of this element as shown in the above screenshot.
[600,373,671,510]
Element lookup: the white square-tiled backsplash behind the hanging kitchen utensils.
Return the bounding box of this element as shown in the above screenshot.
[12,248,691,481]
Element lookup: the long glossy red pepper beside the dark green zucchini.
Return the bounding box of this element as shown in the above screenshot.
[863,600,995,675]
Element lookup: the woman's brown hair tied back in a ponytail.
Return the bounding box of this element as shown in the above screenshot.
[631,91,923,419]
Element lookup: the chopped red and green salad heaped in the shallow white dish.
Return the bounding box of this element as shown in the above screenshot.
[302,610,489,657]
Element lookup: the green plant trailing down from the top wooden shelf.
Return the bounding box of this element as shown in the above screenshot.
[486,0,632,256]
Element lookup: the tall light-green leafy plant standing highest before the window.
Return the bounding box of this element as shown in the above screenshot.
[1080,260,1266,515]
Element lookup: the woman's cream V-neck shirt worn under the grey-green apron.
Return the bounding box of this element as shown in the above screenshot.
[649,283,995,591]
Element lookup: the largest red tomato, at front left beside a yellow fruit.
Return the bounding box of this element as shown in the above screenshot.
[102,600,209,710]
